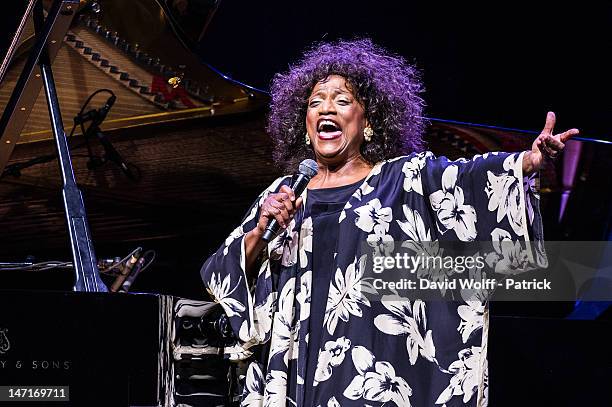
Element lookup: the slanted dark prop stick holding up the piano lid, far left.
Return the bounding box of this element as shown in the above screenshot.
[0,0,108,292]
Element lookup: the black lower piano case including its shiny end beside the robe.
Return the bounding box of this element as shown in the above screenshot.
[0,290,230,407]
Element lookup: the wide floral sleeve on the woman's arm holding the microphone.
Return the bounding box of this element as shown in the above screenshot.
[200,177,289,359]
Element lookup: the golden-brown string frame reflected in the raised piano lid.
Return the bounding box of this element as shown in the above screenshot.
[0,0,268,143]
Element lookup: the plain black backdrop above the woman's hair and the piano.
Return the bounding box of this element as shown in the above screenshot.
[0,0,612,140]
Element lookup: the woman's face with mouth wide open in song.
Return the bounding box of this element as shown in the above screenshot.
[306,75,367,165]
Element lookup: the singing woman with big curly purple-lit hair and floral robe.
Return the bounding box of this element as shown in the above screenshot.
[201,40,578,407]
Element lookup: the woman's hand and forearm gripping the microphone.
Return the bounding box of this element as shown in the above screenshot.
[245,185,303,276]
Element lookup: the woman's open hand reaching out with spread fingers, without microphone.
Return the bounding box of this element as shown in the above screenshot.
[523,112,579,175]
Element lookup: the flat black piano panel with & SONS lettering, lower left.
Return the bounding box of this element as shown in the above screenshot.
[0,290,160,406]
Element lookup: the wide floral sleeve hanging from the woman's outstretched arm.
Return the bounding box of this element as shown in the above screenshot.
[421,152,546,274]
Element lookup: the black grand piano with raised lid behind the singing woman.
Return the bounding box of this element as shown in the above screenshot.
[0,0,612,406]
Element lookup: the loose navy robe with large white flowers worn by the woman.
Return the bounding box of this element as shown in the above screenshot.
[201,152,542,407]
